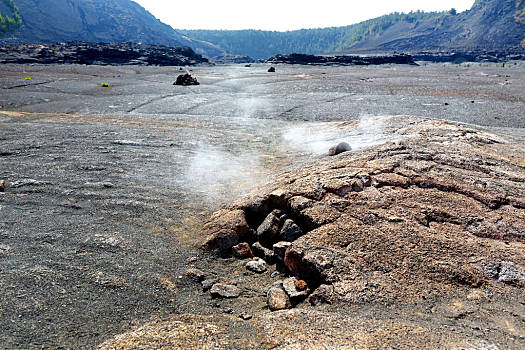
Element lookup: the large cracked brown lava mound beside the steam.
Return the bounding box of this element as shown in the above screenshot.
[201,117,525,304]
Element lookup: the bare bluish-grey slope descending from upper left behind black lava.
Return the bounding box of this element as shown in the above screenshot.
[0,0,223,57]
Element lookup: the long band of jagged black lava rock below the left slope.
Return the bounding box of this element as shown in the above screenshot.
[0,42,208,66]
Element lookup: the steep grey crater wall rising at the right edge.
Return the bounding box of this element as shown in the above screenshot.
[349,0,525,51]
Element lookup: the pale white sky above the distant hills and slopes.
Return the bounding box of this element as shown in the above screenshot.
[135,0,474,30]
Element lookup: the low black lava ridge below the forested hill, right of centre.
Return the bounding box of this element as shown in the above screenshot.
[267,53,415,65]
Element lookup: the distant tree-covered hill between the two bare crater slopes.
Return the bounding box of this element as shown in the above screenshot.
[181,11,446,58]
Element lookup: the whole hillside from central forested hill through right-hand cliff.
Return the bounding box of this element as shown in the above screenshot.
[181,0,525,58]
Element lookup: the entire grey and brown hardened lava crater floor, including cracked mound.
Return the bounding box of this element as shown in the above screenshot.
[0,64,525,349]
